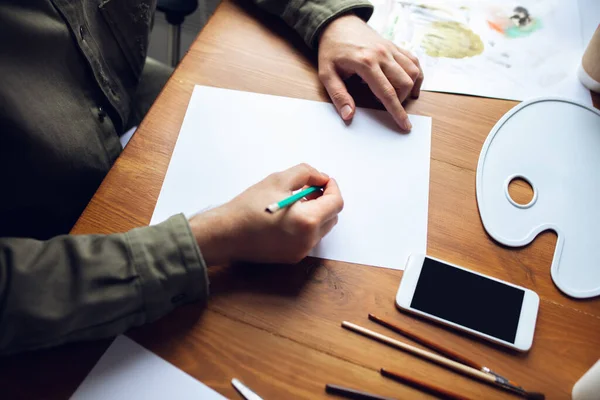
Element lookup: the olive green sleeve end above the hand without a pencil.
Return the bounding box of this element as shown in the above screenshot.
[252,0,373,48]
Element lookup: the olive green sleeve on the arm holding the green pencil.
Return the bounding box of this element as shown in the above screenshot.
[0,215,208,354]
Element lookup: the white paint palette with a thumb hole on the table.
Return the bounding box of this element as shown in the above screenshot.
[476,98,600,298]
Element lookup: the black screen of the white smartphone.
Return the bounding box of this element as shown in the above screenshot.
[410,257,525,344]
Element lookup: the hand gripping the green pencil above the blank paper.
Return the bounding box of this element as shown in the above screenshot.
[190,164,344,265]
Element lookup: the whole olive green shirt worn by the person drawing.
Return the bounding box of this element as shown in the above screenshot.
[0,0,372,354]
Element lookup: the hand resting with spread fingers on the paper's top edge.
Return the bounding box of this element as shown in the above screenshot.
[319,14,423,131]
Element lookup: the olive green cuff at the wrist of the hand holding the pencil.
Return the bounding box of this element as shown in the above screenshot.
[126,214,209,323]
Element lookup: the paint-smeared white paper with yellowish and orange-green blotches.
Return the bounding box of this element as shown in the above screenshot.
[370,0,591,103]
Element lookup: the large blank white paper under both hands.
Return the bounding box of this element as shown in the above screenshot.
[151,86,431,269]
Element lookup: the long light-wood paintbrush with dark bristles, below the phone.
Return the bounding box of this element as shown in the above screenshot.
[342,321,544,399]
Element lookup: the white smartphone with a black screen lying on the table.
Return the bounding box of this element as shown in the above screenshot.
[396,254,540,351]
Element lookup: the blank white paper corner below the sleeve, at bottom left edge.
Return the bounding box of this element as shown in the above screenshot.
[71,336,226,400]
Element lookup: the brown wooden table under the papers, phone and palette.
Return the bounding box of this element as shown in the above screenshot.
[0,0,600,399]
